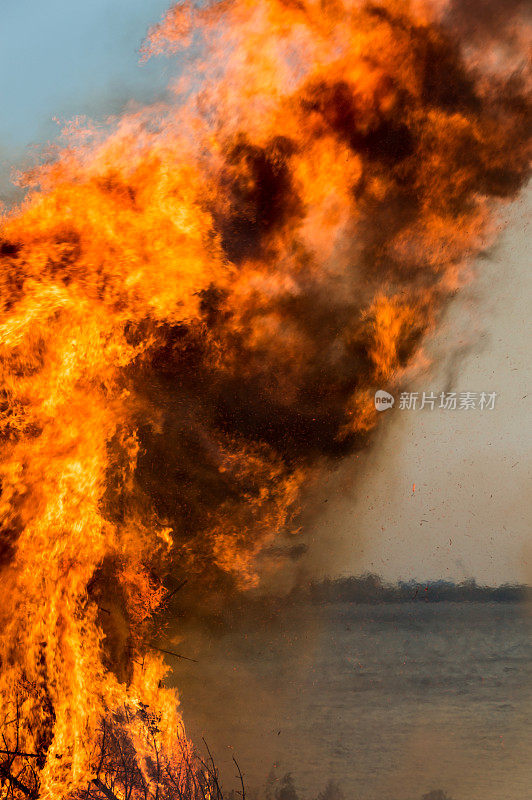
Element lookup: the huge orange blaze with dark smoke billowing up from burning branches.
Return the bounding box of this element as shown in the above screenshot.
[0,0,530,800]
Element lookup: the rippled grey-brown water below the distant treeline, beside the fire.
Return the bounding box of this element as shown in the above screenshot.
[173,602,532,800]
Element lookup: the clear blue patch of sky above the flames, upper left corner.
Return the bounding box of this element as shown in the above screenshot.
[0,0,171,190]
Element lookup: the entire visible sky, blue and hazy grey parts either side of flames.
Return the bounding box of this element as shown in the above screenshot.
[0,0,532,582]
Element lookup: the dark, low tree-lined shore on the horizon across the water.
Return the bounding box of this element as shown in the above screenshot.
[290,574,532,605]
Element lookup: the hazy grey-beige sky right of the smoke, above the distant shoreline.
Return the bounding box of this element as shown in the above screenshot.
[313,195,532,583]
